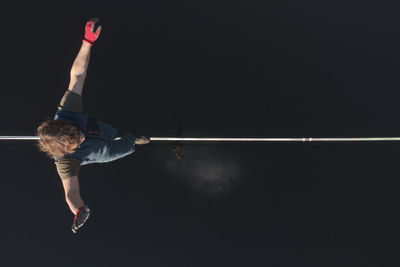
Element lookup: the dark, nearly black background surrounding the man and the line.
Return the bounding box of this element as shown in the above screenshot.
[0,0,400,267]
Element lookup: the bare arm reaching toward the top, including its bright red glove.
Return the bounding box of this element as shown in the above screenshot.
[68,19,101,95]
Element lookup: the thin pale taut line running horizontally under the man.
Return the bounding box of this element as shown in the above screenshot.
[0,136,400,142]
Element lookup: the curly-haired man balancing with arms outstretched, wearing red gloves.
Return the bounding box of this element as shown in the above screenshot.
[37,19,150,233]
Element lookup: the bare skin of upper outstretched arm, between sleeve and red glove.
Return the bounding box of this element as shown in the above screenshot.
[68,42,91,98]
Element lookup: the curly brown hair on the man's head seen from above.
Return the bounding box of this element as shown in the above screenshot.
[37,119,80,158]
